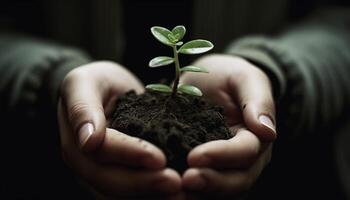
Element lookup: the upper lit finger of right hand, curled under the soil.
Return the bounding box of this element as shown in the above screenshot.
[187,128,262,169]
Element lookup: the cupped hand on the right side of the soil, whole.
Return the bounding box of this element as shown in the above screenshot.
[182,55,276,196]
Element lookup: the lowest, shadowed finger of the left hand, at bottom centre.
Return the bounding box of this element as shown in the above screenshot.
[88,167,181,197]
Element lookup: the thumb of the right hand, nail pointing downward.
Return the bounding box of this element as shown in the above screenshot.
[229,65,277,142]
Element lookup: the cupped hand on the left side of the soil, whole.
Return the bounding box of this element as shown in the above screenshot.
[58,62,181,198]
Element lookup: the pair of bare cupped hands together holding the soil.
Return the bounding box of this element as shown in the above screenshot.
[58,55,276,199]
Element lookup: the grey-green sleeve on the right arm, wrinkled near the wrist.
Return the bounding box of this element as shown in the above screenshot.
[227,8,350,136]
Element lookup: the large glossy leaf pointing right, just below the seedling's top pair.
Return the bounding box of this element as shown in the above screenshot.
[178,39,214,54]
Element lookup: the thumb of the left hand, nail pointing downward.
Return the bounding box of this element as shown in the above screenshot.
[61,72,106,151]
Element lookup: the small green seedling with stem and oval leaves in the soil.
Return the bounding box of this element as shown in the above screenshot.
[146,25,214,97]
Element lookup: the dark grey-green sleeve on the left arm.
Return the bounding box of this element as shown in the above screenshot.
[0,34,90,117]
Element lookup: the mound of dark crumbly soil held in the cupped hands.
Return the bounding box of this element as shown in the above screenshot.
[111,91,230,173]
